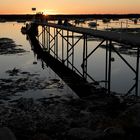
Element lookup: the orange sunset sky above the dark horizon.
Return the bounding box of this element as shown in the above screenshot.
[0,0,140,14]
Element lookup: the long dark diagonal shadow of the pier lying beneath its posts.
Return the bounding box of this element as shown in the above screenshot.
[28,35,105,97]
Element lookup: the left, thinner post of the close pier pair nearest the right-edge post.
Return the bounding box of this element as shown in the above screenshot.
[105,40,108,89]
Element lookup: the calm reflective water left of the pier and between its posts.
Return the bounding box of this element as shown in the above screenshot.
[0,21,140,99]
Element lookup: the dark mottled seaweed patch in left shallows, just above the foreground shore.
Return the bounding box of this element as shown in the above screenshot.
[0,68,63,100]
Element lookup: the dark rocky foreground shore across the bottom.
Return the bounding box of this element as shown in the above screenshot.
[0,95,140,140]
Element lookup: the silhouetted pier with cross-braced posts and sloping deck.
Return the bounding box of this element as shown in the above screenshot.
[25,21,140,95]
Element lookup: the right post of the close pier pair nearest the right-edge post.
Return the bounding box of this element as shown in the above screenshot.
[108,41,112,94]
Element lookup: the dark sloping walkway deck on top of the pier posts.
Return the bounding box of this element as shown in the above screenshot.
[37,23,140,47]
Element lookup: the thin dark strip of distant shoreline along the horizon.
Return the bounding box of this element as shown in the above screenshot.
[0,14,140,21]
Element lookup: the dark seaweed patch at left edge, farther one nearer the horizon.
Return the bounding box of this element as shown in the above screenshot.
[0,38,26,55]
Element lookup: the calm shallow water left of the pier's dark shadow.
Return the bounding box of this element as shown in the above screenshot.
[0,22,76,103]
